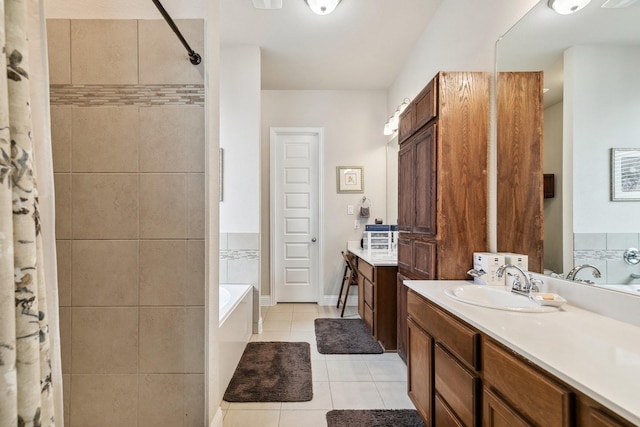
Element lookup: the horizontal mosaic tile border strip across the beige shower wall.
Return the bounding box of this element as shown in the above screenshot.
[49,85,204,107]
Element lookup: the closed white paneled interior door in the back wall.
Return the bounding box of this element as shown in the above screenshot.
[271,128,322,302]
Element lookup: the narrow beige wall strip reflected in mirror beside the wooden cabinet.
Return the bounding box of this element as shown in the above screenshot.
[543,102,573,273]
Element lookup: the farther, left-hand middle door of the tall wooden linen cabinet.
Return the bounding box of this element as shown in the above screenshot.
[398,140,415,232]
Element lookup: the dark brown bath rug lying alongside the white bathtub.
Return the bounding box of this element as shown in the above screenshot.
[223,342,313,402]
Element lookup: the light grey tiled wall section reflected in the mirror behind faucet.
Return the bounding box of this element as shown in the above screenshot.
[576,233,640,285]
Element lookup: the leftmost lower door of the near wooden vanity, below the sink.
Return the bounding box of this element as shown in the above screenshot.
[407,319,433,425]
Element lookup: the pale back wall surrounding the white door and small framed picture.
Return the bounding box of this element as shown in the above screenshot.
[260,90,387,295]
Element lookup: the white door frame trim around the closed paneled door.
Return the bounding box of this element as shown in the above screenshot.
[269,127,325,306]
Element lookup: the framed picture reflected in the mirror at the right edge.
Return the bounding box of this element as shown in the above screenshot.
[611,148,640,201]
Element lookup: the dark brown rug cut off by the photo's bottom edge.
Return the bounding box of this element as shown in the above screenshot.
[327,409,425,427]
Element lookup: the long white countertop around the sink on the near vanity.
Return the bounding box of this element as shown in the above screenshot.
[404,280,640,425]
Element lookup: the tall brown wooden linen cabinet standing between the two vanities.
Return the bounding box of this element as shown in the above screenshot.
[397,72,489,361]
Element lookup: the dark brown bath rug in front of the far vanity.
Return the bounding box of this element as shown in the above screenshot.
[315,319,383,354]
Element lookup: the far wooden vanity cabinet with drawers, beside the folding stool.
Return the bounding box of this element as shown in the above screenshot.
[357,258,398,351]
